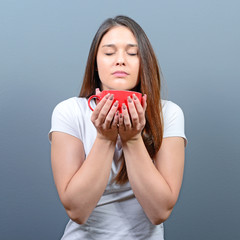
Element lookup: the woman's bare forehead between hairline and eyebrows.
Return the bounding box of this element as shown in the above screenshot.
[100,26,137,45]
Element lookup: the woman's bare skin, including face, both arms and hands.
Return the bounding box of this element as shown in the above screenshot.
[51,26,184,224]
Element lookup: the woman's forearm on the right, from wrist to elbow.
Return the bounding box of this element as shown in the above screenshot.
[123,138,174,224]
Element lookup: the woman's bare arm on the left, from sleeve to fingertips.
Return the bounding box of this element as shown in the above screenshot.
[51,93,118,224]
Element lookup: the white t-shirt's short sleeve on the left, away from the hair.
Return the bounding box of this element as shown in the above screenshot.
[48,99,82,143]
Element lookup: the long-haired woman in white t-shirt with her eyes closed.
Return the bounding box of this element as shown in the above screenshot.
[49,16,186,240]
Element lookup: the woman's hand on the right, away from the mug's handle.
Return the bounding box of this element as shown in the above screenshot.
[119,94,147,144]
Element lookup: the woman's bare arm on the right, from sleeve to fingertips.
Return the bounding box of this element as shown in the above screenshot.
[119,95,184,224]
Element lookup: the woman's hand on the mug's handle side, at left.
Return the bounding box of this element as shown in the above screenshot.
[91,89,119,142]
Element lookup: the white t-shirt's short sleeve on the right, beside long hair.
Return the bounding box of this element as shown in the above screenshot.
[163,101,187,145]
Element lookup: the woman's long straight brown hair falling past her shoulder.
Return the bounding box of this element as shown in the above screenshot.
[79,16,163,184]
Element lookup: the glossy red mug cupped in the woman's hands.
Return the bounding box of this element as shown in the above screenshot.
[88,90,142,113]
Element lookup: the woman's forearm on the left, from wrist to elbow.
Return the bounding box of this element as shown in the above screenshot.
[63,138,115,223]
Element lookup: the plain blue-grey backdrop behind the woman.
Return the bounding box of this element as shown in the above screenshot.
[0,0,240,240]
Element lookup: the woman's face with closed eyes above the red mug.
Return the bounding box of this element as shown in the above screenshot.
[97,26,140,90]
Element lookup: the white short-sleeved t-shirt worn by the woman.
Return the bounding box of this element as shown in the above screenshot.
[49,97,186,240]
